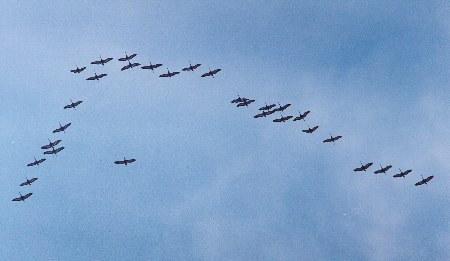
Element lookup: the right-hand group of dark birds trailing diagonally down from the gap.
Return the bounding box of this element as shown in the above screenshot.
[231,95,434,186]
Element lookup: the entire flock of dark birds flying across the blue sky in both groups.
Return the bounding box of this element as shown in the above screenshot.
[13,50,433,201]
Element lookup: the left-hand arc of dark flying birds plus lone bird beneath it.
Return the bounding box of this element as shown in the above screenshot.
[12,53,221,201]
